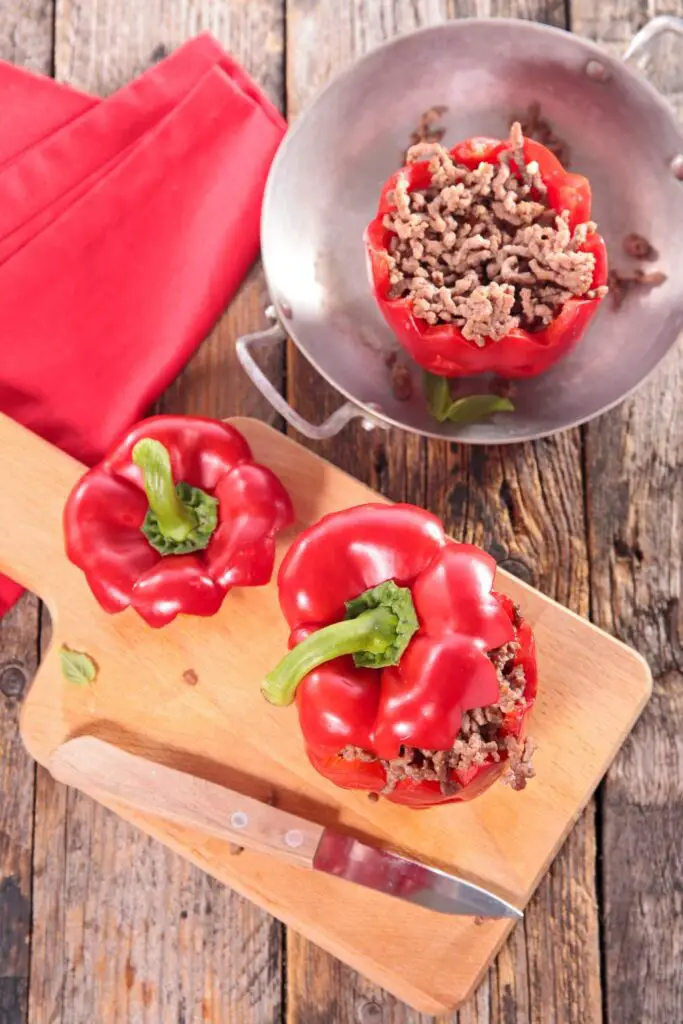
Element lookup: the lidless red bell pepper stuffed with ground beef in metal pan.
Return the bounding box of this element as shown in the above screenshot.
[366,124,607,377]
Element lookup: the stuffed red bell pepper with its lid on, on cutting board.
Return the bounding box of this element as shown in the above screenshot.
[263,505,537,807]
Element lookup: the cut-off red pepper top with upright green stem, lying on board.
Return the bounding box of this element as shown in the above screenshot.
[63,416,294,627]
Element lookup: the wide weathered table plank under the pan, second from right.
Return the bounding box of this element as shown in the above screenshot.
[287,0,601,1024]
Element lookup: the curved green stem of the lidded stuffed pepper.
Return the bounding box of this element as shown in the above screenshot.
[261,607,398,707]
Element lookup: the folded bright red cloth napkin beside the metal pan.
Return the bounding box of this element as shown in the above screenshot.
[0,36,286,614]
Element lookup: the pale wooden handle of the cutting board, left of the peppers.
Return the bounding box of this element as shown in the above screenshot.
[0,413,84,600]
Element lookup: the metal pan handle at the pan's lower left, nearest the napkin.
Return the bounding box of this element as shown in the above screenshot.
[236,306,385,441]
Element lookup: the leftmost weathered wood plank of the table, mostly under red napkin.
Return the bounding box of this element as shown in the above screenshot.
[0,8,53,1024]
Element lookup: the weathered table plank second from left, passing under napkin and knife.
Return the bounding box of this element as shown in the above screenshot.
[26,0,283,1024]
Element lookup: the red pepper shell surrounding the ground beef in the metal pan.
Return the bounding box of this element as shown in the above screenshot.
[366,138,607,377]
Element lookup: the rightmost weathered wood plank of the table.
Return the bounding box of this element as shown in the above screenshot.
[572,0,683,1024]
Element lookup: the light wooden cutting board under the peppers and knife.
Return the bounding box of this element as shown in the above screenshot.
[0,416,651,1014]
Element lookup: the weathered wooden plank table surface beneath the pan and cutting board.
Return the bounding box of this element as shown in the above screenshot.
[0,0,683,1024]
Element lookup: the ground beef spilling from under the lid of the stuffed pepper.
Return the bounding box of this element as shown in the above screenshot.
[340,641,533,797]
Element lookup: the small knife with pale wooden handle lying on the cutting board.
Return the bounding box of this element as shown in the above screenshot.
[48,736,522,920]
